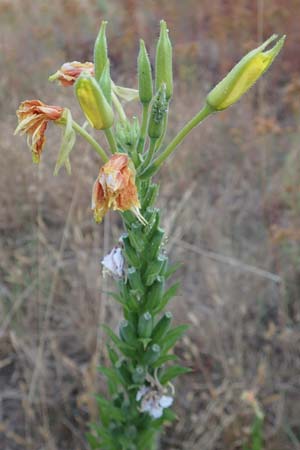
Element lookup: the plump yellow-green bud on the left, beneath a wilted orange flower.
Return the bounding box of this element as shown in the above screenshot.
[75,73,114,130]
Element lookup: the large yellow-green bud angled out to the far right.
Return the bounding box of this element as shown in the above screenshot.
[206,35,285,111]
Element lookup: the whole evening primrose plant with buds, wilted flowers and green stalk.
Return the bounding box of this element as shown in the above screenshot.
[16,20,285,450]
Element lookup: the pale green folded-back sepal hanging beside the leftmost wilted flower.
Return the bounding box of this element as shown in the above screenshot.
[54,108,76,175]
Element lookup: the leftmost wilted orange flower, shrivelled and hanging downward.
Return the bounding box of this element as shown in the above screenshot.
[15,100,64,163]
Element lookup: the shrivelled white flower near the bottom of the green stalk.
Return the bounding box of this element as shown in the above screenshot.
[136,386,173,419]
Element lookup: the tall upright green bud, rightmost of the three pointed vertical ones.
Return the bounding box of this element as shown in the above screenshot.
[155,20,173,101]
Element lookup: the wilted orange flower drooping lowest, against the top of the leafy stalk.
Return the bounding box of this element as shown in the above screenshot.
[92,153,145,223]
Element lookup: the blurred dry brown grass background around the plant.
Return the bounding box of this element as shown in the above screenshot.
[0,0,300,450]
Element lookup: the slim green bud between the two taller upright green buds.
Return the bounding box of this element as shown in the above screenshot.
[138,39,153,105]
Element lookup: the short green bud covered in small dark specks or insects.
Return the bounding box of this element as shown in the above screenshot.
[148,83,168,139]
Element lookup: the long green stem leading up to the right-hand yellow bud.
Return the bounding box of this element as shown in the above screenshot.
[142,104,214,177]
